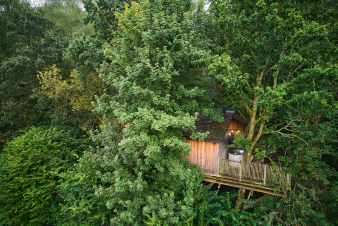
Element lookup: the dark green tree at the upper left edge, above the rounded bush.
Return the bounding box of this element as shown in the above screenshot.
[0,0,65,143]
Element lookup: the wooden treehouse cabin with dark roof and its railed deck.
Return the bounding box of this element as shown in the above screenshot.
[187,111,291,195]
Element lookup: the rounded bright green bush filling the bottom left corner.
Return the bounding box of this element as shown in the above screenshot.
[0,128,86,225]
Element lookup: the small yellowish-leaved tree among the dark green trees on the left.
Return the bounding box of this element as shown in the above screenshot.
[34,65,103,132]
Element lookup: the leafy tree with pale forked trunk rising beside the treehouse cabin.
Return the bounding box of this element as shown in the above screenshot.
[209,1,337,206]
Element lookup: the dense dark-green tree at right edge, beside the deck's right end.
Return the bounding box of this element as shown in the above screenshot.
[260,66,338,225]
